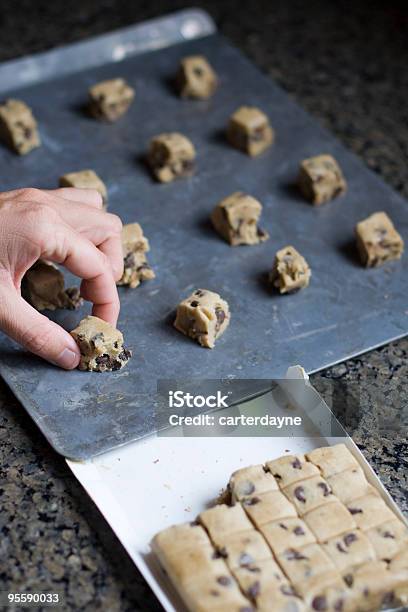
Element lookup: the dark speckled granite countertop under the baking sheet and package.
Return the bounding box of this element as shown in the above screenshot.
[0,0,408,612]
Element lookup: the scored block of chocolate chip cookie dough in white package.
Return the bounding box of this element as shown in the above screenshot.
[152,444,408,612]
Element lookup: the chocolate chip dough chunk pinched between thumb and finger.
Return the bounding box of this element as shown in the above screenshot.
[71,316,132,372]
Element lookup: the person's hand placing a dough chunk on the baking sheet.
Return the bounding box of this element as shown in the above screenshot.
[0,188,123,370]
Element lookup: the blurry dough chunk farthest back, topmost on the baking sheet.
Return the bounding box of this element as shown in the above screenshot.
[176,55,218,100]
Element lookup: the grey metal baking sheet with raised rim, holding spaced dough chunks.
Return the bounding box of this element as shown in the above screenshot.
[0,11,408,459]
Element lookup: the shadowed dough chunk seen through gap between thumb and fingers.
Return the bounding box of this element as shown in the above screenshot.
[21,259,83,311]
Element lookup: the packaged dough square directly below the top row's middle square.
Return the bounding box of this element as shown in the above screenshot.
[283,476,337,516]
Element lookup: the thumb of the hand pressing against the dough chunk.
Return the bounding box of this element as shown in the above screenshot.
[0,285,80,370]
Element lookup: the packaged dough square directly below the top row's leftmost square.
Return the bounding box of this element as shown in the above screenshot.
[242,491,297,529]
